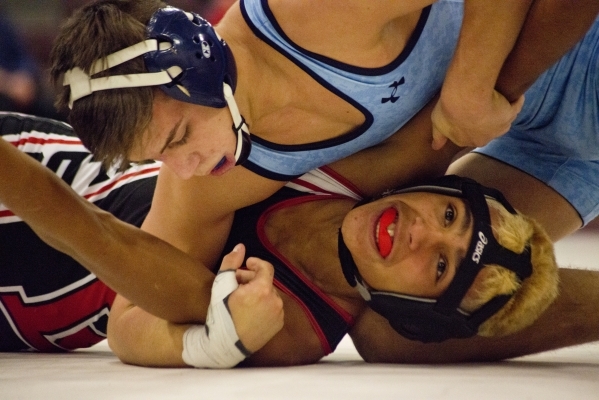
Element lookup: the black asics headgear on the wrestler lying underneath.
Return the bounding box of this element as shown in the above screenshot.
[338,175,532,343]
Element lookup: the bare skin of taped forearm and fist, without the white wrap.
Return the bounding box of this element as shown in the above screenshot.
[108,246,284,367]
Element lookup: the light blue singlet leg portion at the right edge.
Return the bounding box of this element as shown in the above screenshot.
[475,15,599,225]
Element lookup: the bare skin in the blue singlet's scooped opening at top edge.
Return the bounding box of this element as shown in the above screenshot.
[269,0,434,67]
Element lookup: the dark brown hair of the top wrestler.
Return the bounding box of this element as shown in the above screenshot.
[51,0,166,167]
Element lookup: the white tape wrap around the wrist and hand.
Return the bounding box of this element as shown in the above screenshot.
[183,270,250,368]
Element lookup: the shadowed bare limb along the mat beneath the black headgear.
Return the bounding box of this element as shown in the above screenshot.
[350,269,599,363]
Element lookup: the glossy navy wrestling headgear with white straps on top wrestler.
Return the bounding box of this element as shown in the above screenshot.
[63,6,251,165]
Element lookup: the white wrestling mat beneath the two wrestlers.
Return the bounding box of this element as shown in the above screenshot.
[0,230,599,400]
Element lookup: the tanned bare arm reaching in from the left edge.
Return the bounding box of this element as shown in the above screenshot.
[0,140,213,322]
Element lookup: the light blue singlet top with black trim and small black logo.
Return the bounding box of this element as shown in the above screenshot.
[240,0,463,180]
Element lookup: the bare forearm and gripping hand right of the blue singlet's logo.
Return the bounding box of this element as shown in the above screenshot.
[432,0,532,149]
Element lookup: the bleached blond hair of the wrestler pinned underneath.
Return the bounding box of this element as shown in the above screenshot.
[460,200,559,336]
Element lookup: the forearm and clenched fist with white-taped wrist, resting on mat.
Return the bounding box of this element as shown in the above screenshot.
[108,253,284,368]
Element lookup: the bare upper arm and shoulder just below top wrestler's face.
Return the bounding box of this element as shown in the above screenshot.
[142,167,285,267]
